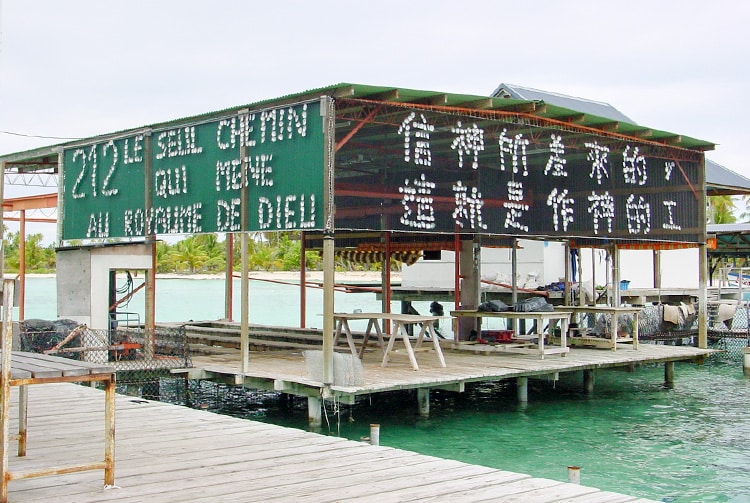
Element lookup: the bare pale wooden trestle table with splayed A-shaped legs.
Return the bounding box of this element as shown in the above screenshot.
[333,313,446,370]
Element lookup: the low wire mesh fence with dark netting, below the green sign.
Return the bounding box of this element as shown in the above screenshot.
[18,320,192,383]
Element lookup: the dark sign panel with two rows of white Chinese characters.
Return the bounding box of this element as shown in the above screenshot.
[337,103,704,242]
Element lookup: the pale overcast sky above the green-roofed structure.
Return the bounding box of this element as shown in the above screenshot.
[0,0,750,241]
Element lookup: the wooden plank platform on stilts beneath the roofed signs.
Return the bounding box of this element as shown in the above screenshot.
[180,340,714,404]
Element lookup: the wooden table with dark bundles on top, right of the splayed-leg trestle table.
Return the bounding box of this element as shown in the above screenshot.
[451,310,571,359]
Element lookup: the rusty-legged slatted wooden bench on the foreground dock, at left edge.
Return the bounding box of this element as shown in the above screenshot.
[0,280,115,503]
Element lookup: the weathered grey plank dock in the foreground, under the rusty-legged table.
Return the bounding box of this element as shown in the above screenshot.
[9,382,664,503]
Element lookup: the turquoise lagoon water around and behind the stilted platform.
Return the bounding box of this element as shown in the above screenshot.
[20,278,750,503]
